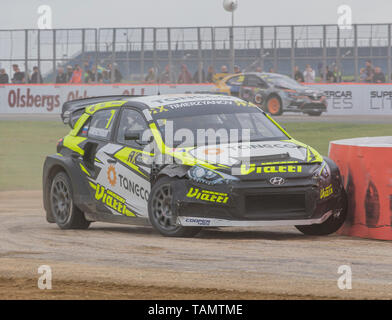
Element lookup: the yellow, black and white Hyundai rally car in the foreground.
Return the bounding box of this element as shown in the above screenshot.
[43,94,347,236]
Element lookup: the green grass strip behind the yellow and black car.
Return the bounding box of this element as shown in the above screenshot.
[0,121,392,191]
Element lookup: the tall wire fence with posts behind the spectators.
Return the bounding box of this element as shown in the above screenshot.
[0,24,392,83]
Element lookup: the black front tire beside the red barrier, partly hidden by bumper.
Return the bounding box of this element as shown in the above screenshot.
[295,195,347,236]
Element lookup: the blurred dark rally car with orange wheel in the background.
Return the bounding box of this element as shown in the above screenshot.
[215,72,327,116]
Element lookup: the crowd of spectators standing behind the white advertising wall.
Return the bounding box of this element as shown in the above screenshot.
[0,59,392,84]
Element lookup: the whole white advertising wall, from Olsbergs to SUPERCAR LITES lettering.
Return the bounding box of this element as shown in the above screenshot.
[0,83,392,115]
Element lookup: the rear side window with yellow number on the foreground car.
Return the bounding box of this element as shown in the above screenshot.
[88,109,118,140]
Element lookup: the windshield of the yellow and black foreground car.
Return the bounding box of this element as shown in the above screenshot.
[156,105,288,147]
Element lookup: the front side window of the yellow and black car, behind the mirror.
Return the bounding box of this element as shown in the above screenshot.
[117,109,148,145]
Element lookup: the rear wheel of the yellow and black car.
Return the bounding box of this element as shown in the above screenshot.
[49,172,91,230]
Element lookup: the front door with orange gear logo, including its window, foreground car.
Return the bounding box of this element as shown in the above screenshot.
[92,108,153,217]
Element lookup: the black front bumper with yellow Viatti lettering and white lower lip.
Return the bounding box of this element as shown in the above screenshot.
[173,180,344,227]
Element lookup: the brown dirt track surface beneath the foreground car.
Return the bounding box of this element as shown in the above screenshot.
[0,191,392,299]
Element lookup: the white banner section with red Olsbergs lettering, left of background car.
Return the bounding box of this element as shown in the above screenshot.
[0,84,215,114]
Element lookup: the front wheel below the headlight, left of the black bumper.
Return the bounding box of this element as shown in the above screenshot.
[148,176,201,237]
